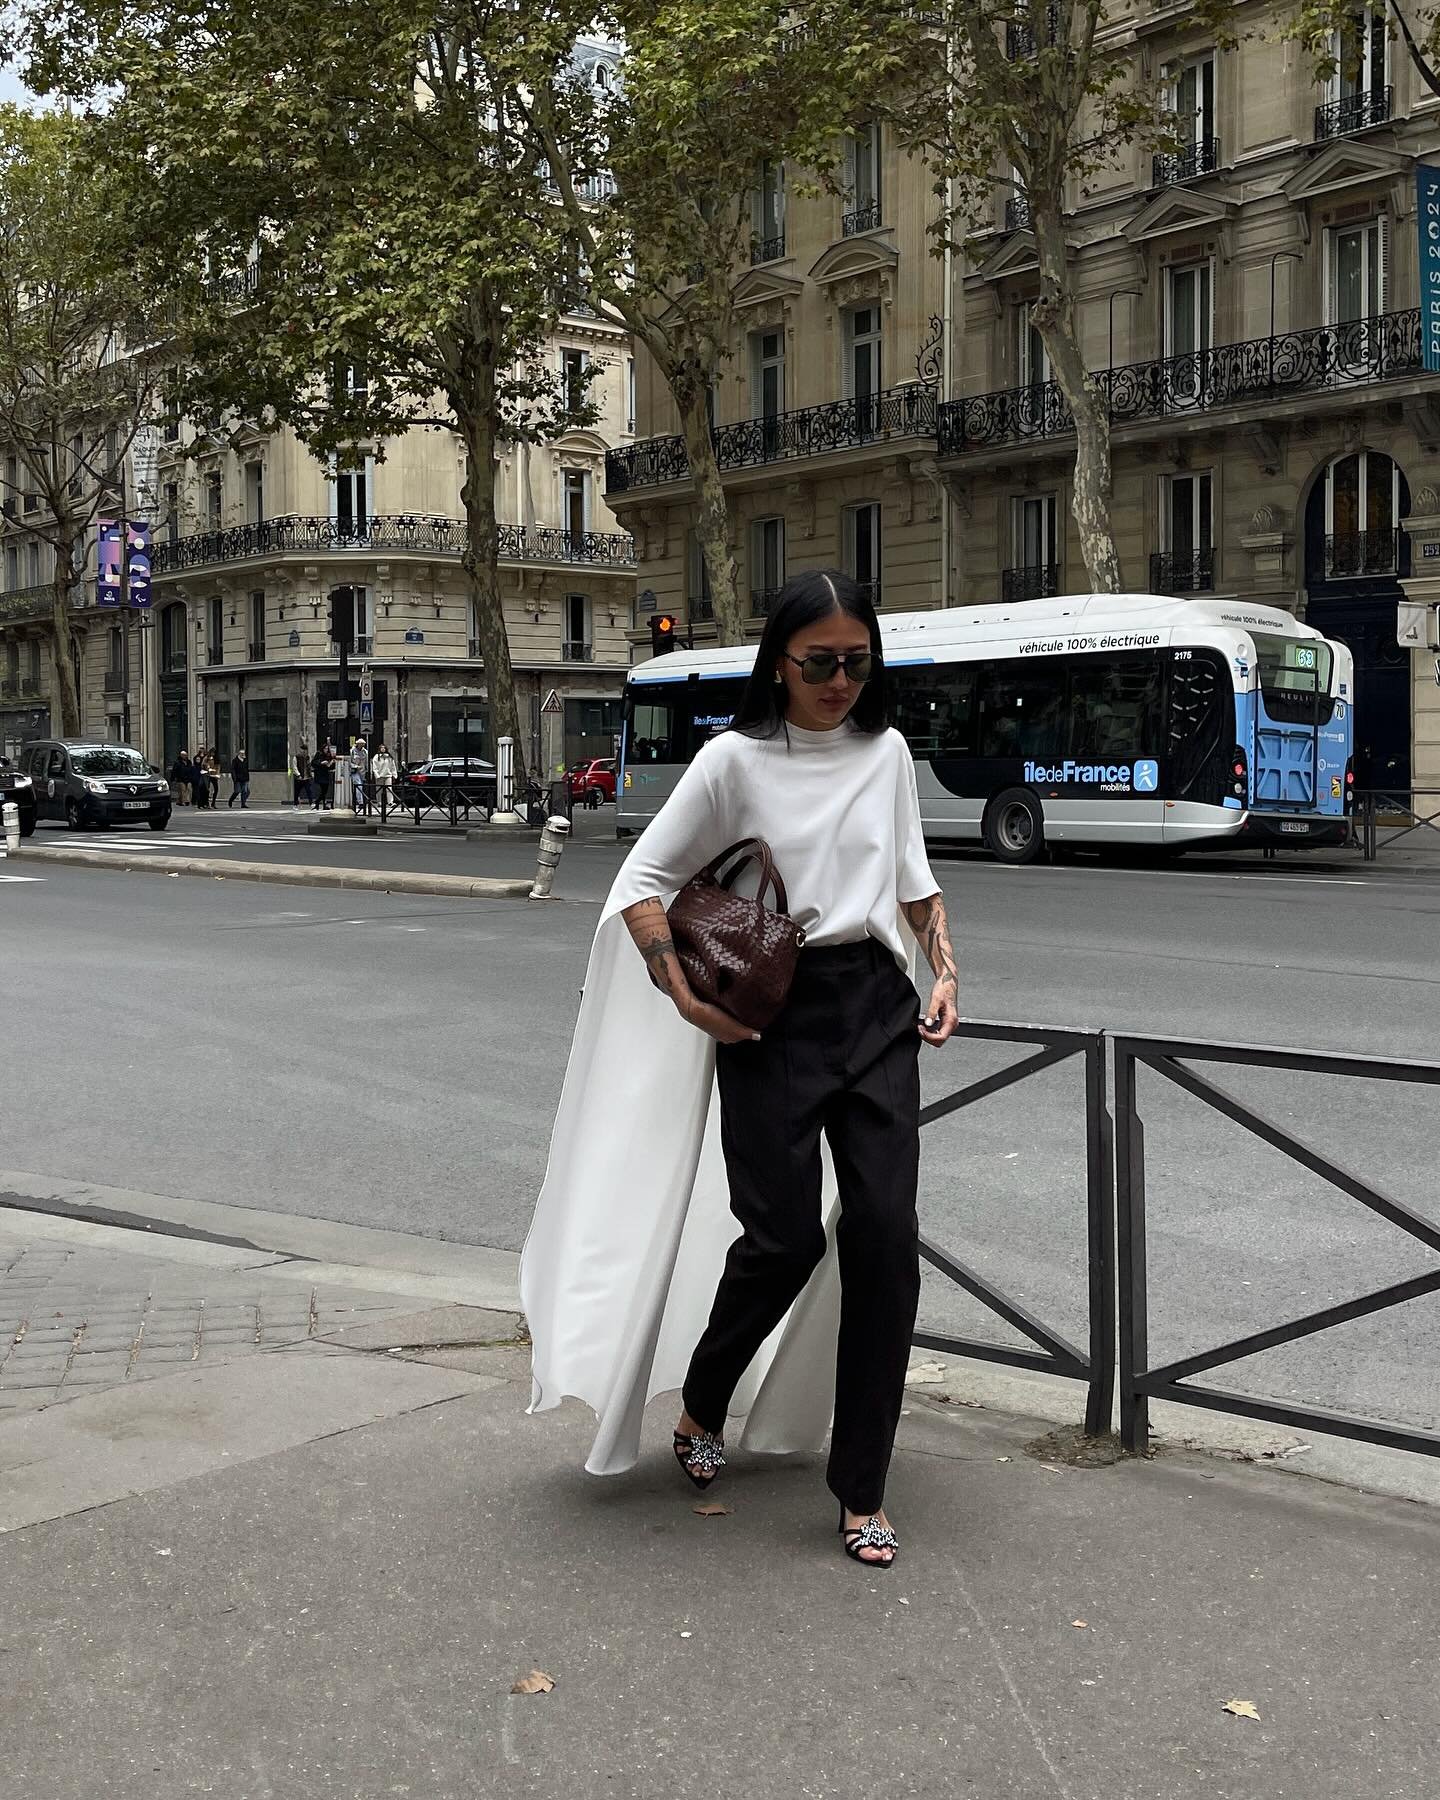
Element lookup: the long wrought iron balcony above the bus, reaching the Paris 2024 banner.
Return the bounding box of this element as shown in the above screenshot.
[938,308,1420,455]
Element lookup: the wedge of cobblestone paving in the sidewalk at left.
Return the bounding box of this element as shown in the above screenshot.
[0,1229,414,1417]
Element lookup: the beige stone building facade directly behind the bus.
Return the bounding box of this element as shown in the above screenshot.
[610,4,1440,788]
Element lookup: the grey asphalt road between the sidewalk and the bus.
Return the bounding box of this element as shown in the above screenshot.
[0,853,1440,1426]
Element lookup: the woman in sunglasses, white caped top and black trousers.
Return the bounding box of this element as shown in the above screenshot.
[520,571,958,1568]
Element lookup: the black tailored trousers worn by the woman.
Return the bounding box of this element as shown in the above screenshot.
[684,940,920,1512]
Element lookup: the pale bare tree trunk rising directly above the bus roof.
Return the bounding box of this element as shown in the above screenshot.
[1031,207,1120,594]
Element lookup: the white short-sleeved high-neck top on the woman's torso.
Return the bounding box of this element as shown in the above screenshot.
[610,724,940,967]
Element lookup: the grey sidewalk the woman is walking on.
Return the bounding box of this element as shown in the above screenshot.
[0,1211,1440,1800]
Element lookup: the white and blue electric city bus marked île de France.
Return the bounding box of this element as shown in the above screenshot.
[616,594,1355,862]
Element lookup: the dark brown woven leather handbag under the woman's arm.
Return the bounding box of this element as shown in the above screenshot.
[670,837,805,1031]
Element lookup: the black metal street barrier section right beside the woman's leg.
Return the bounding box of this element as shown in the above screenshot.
[913,1021,1116,1436]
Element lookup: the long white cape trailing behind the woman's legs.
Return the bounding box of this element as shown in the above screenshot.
[520,877,900,1474]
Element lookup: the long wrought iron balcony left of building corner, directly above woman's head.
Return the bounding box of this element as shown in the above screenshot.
[605,382,938,493]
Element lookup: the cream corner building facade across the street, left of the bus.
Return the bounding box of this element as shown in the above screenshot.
[0,311,637,799]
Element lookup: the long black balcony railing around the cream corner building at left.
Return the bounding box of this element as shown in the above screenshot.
[153,513,635,574]
